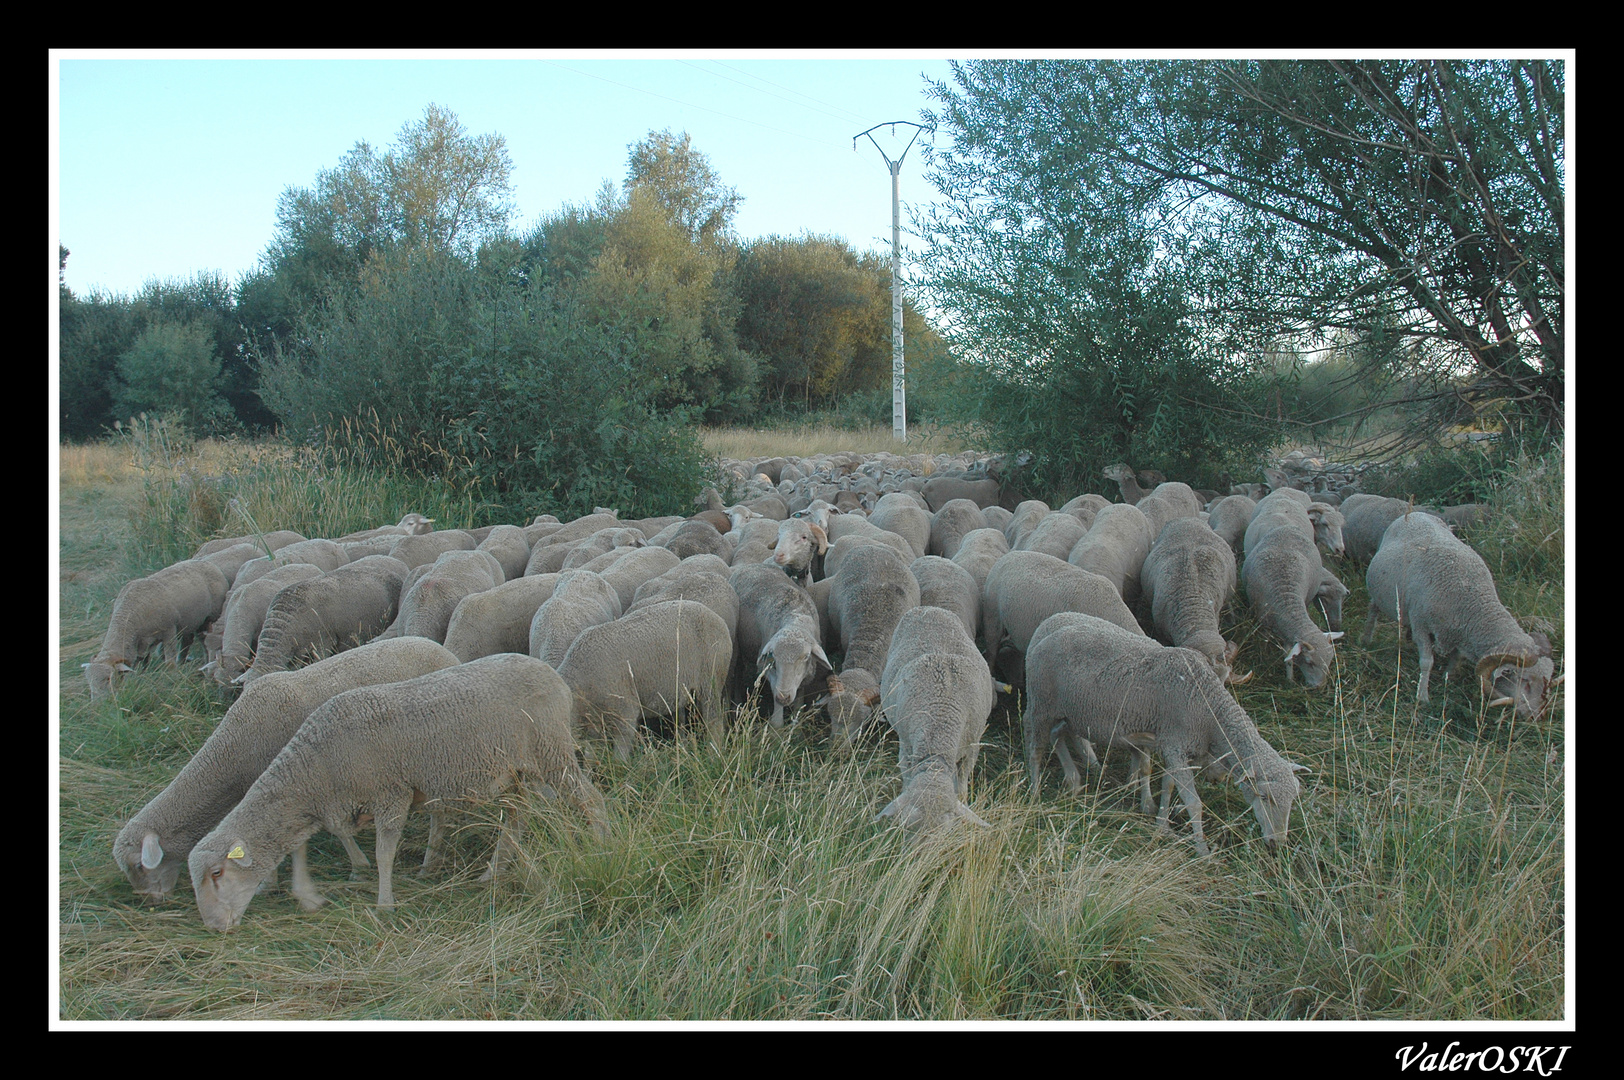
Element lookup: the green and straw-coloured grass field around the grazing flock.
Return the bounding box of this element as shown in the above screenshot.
[57,432,1574,1023]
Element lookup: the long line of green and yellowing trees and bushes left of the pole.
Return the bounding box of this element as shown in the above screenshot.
[60,106,948,510]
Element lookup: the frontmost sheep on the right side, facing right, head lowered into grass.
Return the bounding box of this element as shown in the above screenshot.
[1021,616,1306,856]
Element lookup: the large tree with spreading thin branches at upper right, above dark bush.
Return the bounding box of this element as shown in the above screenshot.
[929,60,1564,448]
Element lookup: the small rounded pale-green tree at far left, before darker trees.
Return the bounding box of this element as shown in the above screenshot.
[112,320,231,435]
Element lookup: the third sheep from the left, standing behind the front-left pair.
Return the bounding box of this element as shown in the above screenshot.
[232,555,412,685]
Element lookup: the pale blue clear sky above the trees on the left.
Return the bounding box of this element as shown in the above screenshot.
[52,50,952,296]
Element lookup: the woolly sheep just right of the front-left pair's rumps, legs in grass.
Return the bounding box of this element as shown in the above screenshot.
[559,599,732,762]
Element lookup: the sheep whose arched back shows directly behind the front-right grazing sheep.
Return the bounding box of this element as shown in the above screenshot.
[981,552,1143,682]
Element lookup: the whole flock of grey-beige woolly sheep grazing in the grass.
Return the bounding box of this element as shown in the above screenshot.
[84,444,1554,931]
